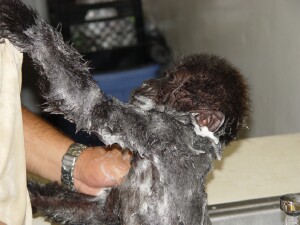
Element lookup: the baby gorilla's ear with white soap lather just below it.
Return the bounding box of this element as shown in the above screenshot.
[194,109,225,132]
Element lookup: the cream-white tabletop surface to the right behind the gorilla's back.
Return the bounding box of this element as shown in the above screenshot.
[206,133,300,204]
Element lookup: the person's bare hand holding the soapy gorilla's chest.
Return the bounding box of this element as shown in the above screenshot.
[74,144,132,195]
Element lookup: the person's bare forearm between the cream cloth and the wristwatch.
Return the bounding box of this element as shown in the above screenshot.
[22,107,73,181]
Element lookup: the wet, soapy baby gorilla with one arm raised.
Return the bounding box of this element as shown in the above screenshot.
[0,0,249,225]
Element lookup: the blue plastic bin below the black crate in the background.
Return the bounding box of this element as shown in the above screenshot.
[93,64,160,102]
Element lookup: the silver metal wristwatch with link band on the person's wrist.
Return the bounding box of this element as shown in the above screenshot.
[61,143,87,191]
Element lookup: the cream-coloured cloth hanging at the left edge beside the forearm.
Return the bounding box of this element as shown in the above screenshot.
[0,40,32,225]
